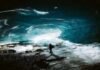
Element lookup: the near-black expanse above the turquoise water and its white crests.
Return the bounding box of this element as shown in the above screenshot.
[0,0,100,18]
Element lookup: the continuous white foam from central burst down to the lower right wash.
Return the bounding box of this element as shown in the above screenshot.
[27,27,100,64]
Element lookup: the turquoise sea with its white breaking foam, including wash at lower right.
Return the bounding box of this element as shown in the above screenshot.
[0,10,100,63]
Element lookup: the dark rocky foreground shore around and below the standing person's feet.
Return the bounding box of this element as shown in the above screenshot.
[0,42,100,70]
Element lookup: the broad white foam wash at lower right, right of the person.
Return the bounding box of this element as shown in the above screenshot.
[59,41,100,64]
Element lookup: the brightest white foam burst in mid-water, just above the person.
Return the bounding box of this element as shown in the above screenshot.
[32,29,61,44]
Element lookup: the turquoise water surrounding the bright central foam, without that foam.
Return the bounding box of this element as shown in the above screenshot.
[0,8,98,43]
